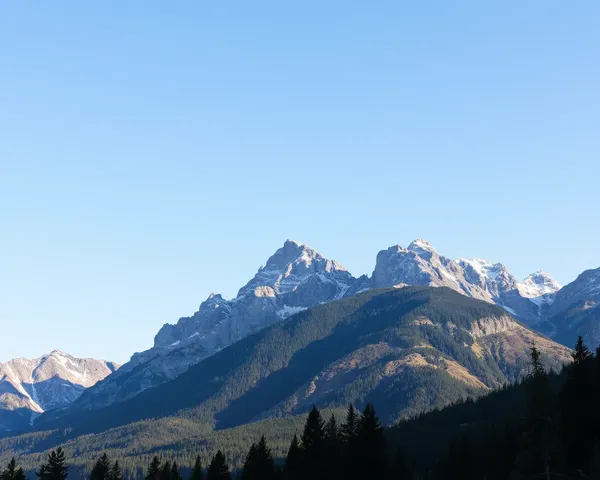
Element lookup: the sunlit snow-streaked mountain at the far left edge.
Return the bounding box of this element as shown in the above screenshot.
[0,350,119,431]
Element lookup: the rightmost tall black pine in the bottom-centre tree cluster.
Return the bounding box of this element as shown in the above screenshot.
[356,403,386,480]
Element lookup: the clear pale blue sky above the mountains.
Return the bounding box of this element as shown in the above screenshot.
[0,0,600,362]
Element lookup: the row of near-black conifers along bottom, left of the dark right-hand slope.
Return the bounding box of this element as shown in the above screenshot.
[0,404,409,480]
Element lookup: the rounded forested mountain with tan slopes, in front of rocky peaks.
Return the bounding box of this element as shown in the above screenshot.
[35,287,570,435]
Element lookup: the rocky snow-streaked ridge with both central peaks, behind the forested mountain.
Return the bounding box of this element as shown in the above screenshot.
[54,240,559,416]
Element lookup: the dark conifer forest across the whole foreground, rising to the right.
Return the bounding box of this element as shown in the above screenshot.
[0,338,600,480]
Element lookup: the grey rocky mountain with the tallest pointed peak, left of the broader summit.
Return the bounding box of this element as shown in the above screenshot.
[65,240,366,409]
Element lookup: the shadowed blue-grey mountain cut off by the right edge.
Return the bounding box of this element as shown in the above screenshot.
[540,268,600,348]
